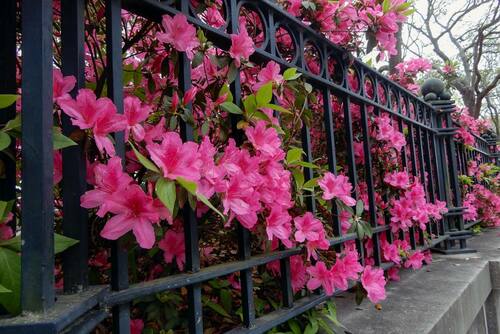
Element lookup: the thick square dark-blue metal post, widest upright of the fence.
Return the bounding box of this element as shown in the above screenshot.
[21,0,55,311]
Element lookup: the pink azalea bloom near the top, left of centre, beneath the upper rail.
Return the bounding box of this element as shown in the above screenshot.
[156,14,200,59]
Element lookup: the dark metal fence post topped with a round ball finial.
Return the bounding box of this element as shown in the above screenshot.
[422,78,476,254]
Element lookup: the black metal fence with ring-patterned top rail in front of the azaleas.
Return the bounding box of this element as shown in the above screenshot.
[0,0,498,334]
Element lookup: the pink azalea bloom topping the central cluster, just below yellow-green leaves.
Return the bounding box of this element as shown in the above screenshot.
[245,121,282,157]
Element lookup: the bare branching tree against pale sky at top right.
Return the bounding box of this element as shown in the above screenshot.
[403,0,500,118]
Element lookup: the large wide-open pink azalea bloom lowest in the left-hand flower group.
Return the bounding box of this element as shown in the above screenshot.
[101,184,167,249]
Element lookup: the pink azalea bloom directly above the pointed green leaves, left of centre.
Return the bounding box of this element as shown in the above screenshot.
[146,132,202,181]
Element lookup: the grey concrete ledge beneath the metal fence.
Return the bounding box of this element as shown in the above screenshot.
[335,229,500,334]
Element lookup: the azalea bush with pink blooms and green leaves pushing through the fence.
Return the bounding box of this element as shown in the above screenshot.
[0,0,498,333]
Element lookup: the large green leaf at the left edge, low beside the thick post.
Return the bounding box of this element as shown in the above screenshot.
[0,247,21,315]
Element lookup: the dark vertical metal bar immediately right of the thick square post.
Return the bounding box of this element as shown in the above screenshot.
[61,0,89,293]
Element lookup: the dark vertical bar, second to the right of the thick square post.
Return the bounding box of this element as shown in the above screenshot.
[106,0,130,334]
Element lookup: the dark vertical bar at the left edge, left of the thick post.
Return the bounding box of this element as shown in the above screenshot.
[0,0,17,207]
